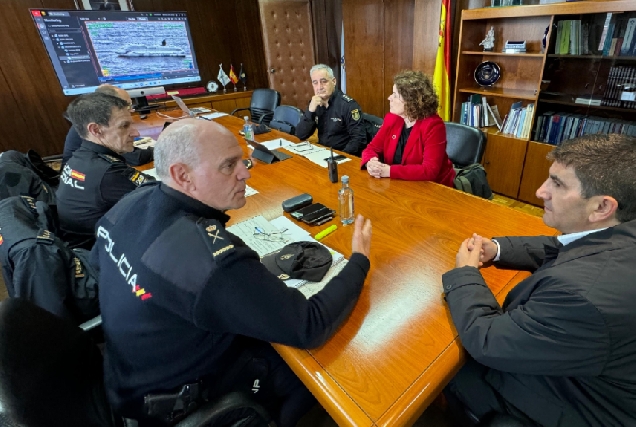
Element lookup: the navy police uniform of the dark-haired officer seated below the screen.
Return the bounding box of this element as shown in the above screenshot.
[56,140,153,248]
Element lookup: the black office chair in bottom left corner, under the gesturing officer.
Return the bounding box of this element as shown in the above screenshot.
[0,298,274,427]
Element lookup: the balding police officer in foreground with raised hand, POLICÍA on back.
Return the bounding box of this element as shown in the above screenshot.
[92,119,371,427]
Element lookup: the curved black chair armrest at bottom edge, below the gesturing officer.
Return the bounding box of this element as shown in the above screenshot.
[175,392,276,427]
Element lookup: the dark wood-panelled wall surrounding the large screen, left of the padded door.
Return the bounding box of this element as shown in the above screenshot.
[0,0,268,155]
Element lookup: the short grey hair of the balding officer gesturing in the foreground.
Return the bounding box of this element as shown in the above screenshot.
[154,123,199,181]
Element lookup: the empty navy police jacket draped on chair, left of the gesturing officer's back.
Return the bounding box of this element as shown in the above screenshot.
[0,196,99,324]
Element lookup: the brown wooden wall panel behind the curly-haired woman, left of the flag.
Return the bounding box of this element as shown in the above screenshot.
[342,0,441,117]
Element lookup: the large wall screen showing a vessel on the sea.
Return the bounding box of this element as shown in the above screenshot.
[29,9,201,97]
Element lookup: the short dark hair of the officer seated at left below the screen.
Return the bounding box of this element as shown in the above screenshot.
[65,92,128,139]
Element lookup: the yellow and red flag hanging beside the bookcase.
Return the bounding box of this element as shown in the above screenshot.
[433,0,452,121]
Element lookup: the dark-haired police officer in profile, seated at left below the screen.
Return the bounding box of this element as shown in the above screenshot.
[56,92,152,248]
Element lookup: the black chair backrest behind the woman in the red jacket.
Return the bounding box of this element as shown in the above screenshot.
[444,122,486,167]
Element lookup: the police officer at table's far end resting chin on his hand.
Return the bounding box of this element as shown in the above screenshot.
[296,64,367,156]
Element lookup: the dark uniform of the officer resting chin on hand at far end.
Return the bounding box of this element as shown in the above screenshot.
[296,89,367,156]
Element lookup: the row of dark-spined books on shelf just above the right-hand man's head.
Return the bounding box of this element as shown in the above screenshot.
[533,111,636,145]
